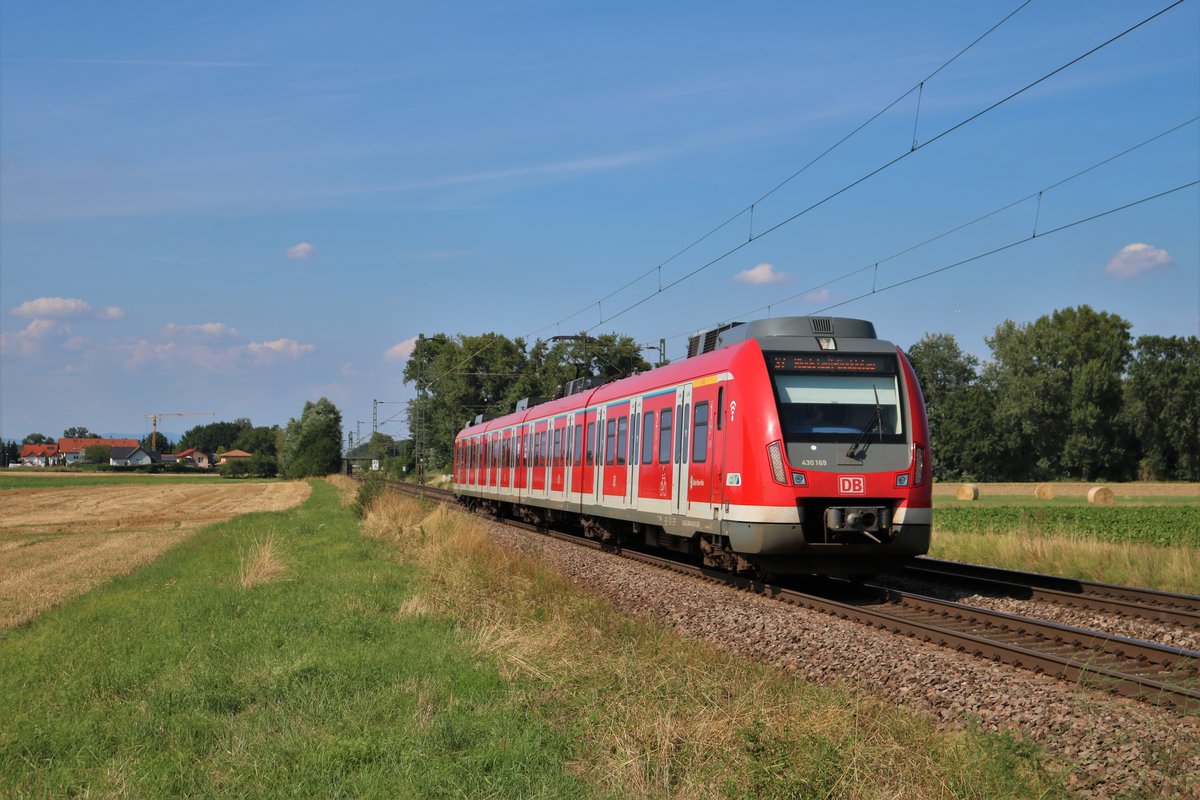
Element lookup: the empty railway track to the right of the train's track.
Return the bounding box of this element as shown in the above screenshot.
[898,558,1200,627]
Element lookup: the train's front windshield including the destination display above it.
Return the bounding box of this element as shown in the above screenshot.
[767,353,905,443]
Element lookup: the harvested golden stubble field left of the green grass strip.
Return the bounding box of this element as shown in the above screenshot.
[0,482,310,630]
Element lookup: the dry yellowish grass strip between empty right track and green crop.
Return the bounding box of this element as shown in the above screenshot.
[929,529,1200,595]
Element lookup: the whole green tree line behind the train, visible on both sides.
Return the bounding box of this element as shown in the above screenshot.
[400,305,1200,481]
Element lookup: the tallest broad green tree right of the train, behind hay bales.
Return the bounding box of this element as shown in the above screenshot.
[984,306,1132,480]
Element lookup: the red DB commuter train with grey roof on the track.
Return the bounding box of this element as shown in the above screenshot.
[454,317,932,575]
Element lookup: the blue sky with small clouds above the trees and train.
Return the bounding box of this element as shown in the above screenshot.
[0,0,1200,439]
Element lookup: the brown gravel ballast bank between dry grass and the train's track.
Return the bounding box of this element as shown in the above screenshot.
[490,523,1200,799]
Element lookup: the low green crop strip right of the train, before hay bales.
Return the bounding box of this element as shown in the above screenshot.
[934,504,1200,547]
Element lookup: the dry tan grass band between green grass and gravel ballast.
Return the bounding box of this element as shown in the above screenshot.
[364,493,1051,798]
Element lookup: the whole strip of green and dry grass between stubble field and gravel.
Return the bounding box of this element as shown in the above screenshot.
[0,482,1061,799]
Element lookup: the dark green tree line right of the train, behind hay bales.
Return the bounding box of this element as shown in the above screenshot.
[908,306,1200,481]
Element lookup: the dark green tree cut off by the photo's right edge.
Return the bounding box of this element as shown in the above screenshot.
[1124,336,1200,481]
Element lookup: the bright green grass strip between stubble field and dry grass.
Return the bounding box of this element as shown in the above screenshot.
[0,479,580,798]
